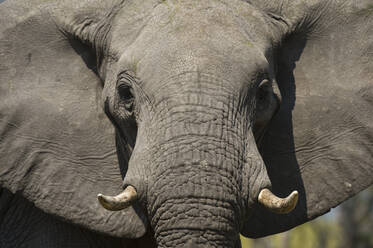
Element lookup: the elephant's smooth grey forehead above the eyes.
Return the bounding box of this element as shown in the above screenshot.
[113,1,267,87]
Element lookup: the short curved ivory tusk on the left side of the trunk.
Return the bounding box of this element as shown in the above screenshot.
[97,186,137,211]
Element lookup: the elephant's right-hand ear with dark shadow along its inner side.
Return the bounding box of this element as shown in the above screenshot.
[242,1,373,238]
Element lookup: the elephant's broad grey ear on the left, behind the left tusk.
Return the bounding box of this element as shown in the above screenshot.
[0,1,146,238]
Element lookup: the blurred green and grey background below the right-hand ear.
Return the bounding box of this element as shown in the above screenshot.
[241,186,373,248]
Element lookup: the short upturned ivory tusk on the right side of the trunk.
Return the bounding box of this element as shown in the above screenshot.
[258,189,298,214]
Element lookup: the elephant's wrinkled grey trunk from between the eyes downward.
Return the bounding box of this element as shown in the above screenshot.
[131,75,269,247]
